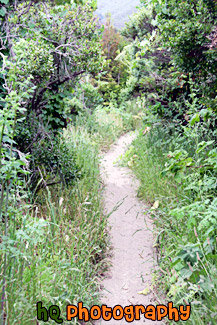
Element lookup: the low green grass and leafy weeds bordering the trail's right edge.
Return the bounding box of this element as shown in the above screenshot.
[126,123,217,324]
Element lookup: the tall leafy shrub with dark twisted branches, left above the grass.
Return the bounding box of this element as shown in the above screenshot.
[1,1,104,189]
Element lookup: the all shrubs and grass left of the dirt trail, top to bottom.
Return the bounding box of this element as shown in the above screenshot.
[0,1,133,324]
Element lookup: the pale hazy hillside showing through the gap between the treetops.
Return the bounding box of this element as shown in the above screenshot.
[96,0,140,29]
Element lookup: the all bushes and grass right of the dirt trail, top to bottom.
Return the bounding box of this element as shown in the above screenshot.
[120,0,217,324]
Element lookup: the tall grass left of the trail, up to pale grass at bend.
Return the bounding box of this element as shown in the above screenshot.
[0,110,133,325]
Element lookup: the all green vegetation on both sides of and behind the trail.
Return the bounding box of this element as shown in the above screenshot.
[0,0,217,325]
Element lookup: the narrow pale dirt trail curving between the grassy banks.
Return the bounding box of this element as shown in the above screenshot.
[97,133,158,325]
